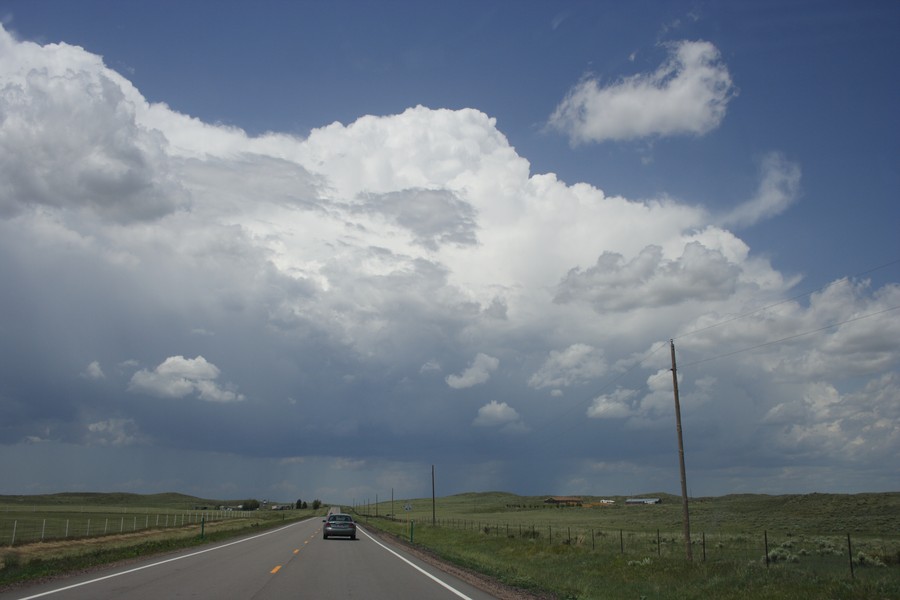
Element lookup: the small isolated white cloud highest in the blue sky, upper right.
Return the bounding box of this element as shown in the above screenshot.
[549,41,735,144]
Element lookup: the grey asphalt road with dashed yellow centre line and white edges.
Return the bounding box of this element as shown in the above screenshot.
[0,518,494,600]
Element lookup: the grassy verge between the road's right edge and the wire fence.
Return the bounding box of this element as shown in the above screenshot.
[367,518,900,600]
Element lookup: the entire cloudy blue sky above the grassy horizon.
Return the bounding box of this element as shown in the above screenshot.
[0,0,900,504]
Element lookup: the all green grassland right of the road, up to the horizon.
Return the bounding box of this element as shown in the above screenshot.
[355,493,900,600]
